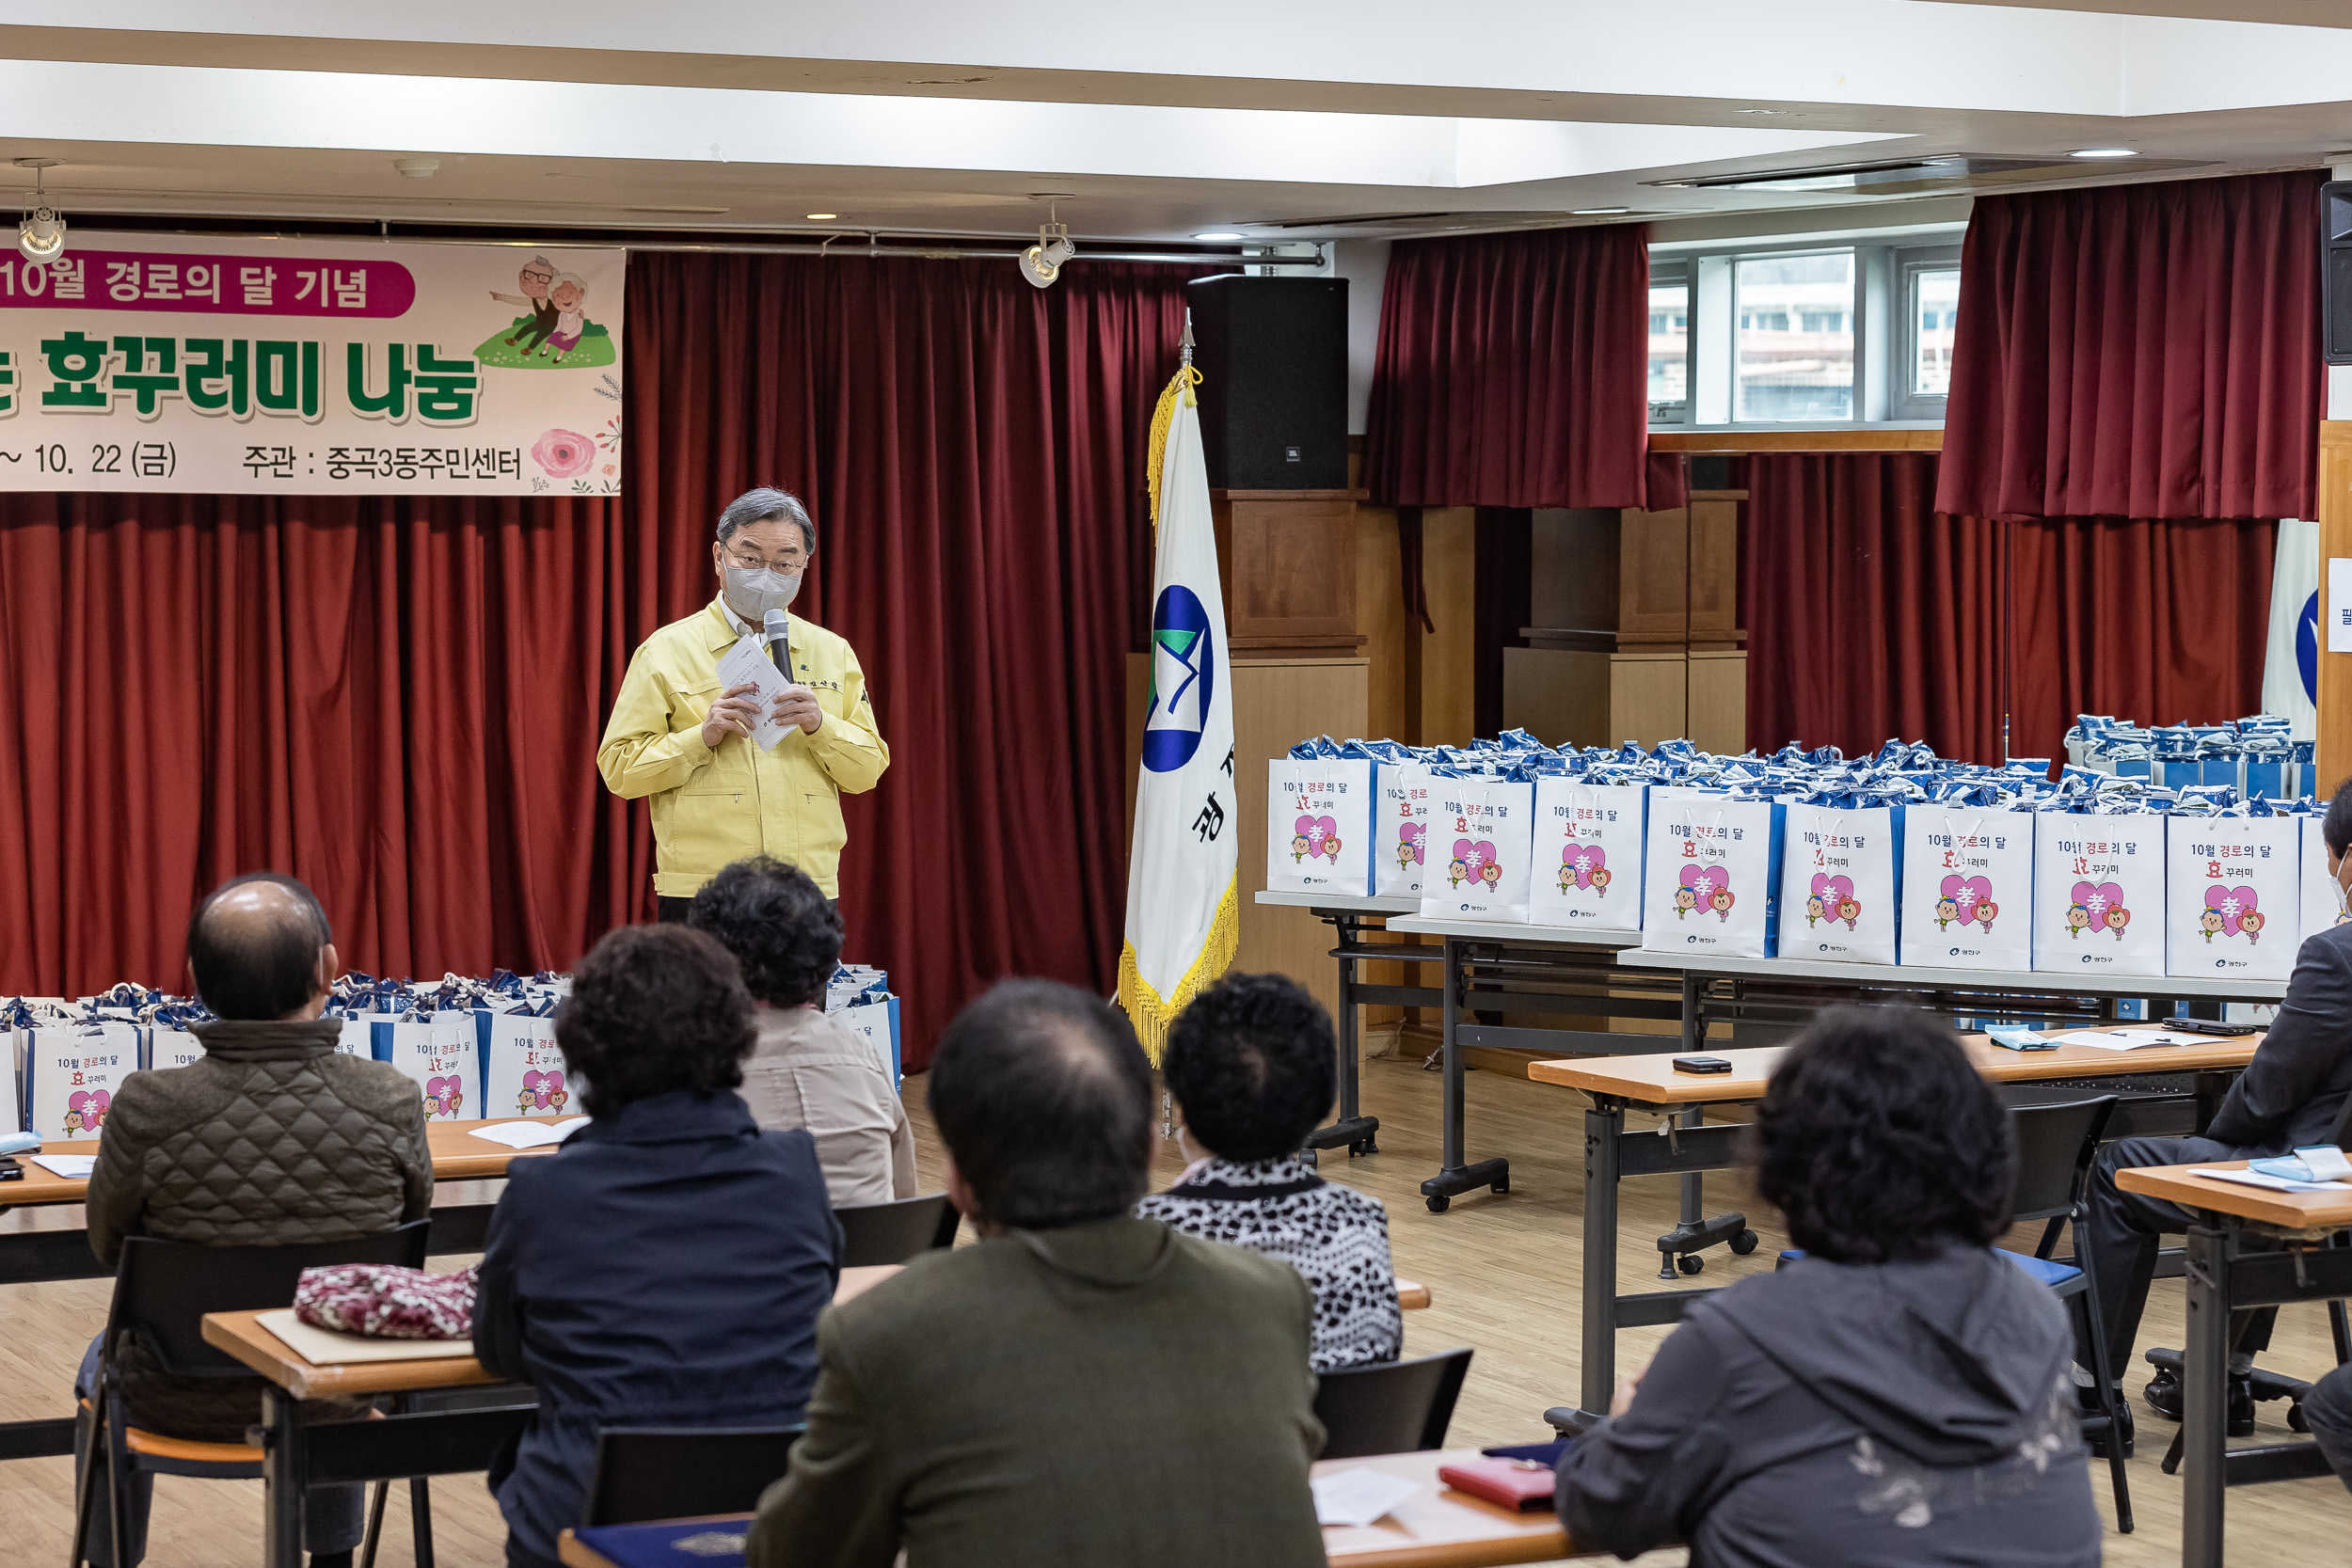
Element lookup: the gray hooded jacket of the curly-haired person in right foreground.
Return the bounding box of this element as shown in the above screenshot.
[1560,1248,2103,1568]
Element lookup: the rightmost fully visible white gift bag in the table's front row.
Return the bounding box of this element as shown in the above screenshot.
[2164,816,2303,980]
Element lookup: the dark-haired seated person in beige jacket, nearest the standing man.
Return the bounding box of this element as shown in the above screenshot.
[687,856,915,1209]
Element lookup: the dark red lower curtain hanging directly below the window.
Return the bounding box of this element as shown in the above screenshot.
[1740,453,2002,762]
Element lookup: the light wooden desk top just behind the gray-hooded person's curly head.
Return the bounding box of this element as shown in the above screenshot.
[1527,1022,2263,1109]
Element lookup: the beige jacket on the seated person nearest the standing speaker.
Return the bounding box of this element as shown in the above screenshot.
[741,1004,915,1209]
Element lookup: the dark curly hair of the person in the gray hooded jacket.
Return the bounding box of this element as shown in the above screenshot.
[1753,1006,2018,1262]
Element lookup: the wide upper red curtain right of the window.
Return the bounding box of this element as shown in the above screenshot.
[1938,169,2327,519]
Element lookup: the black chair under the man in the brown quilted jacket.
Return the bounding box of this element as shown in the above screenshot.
[73,1220,433,1568]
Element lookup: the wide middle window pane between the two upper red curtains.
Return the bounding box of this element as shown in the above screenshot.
[1731,251,1853,423]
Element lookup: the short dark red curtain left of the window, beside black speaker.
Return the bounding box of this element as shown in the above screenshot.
[1364,223,1673,508]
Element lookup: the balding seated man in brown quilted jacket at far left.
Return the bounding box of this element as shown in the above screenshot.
[75,872,433,1568]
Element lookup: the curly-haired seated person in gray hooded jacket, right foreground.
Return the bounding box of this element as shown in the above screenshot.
[1557,1008,2101,1568]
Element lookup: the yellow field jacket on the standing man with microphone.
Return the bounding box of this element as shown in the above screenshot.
[596,599,889,898]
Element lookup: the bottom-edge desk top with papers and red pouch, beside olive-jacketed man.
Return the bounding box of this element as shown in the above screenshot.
[558,1449,1576,1568]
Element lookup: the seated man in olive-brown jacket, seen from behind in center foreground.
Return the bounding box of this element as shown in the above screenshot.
[746,980,1325,1568]
